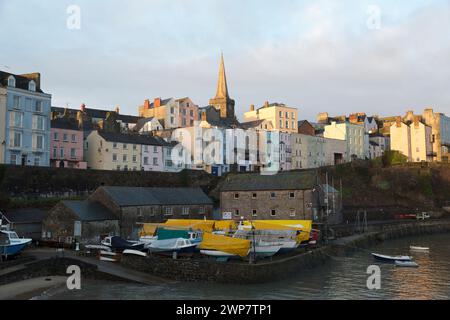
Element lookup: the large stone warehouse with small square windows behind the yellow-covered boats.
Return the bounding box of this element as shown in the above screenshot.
[220,171,324,220]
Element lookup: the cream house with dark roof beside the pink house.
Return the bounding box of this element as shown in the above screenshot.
[86,131,141,171]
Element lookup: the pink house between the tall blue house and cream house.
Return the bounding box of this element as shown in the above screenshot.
[50,118,87,169]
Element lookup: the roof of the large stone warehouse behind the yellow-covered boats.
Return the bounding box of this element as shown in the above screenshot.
[221,171,316,191]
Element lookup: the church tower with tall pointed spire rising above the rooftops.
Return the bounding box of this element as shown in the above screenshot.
[209,54,235,120]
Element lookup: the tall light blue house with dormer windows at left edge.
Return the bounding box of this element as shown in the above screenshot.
[0,71,51,166]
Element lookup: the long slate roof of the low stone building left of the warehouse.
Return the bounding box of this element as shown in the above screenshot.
[101,187,213,207]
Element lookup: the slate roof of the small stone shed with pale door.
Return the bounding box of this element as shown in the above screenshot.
[62,201,118,221]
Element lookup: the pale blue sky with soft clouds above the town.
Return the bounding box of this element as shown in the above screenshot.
[0,0,450,121]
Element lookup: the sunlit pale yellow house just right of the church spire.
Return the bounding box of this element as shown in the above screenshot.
[244,101,298,133]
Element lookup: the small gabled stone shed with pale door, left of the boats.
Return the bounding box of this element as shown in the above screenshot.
[42,201,120,244]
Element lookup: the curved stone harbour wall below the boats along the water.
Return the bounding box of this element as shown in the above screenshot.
[121,220,450,284]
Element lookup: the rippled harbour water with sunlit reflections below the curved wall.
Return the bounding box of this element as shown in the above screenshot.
[36,234,450,300]
